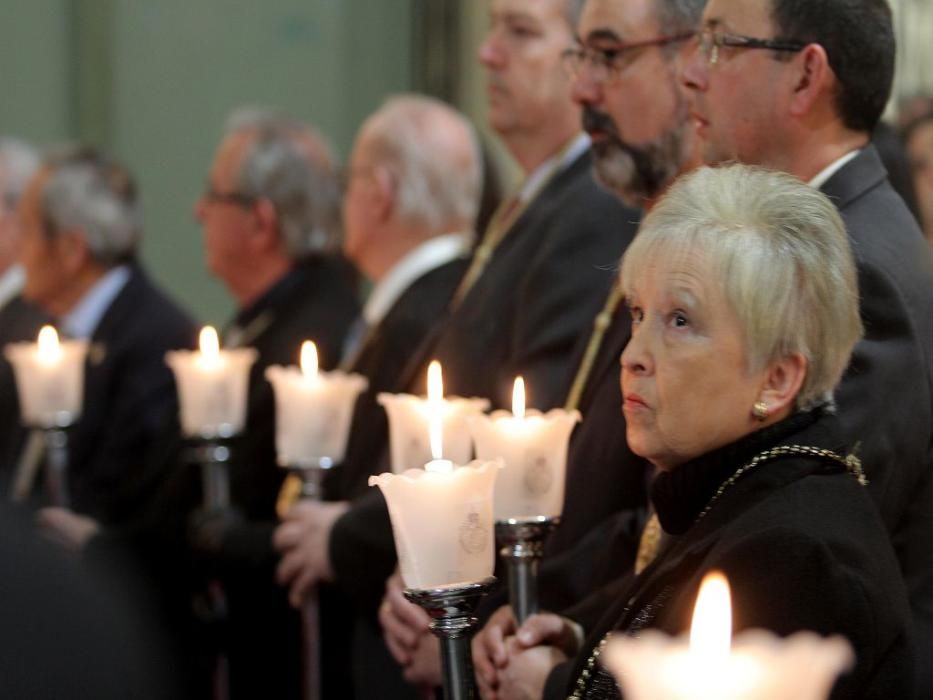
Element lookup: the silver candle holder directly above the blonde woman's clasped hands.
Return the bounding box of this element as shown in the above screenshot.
[496,515,560,624]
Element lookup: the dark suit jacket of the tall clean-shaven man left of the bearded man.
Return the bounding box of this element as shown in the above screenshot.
[411,153,638,409]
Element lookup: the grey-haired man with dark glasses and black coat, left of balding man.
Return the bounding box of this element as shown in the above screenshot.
[44,112,358,698]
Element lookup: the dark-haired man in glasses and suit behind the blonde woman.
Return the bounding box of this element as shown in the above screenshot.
[683,0,933,697]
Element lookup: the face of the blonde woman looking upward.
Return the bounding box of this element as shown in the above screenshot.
[621,252,767,470]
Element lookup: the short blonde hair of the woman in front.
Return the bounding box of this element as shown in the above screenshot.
[622,165,862,410]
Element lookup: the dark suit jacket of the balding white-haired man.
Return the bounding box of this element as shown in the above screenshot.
[324,258,467,501]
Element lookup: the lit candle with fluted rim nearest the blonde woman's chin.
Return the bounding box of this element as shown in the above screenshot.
[469,377,580,520]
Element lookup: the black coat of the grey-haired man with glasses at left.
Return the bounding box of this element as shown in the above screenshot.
[88,256,359,699]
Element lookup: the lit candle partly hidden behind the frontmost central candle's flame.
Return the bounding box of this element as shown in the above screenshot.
[377,360,489,474]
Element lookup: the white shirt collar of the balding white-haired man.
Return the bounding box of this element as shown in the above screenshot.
[363,233,471,326]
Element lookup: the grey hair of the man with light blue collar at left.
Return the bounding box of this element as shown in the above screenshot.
[40,149,142,267]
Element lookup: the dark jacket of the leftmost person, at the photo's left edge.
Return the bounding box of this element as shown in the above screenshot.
[0,296,49,484]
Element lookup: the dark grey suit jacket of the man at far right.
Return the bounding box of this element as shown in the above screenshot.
[822,146,933,697]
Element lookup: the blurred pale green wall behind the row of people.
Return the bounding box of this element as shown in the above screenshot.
[0,0,933,323]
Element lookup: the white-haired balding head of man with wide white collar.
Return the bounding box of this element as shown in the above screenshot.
[361,95,482,231]
